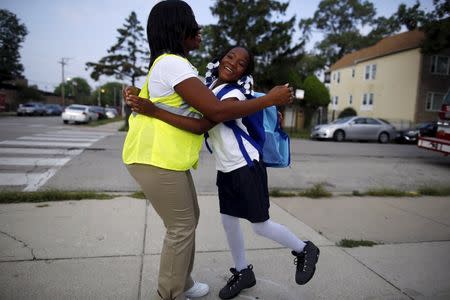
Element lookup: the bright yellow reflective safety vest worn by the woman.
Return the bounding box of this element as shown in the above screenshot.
[122,54,203,171]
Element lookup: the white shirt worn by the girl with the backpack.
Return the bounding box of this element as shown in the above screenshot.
[208,84,259,173]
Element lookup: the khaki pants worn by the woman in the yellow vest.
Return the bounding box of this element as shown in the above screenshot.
[127,164,200,300]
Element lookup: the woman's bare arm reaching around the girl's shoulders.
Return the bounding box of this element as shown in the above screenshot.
[175,77,294,123]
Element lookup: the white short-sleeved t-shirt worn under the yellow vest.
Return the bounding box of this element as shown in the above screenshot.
[148,55,198,98]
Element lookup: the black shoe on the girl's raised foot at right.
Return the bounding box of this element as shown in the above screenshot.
[292,241,320,284]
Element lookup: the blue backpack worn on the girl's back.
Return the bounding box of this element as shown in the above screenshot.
[205,84,291,168]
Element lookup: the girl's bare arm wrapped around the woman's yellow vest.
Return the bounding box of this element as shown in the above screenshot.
[126,94,216,134]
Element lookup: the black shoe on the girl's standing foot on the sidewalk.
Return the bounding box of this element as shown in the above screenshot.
[219,265,256,299]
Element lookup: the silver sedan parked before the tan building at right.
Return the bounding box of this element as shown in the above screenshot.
[311,117,397,143]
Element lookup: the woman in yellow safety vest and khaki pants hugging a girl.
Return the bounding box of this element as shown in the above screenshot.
[122,0,293,300]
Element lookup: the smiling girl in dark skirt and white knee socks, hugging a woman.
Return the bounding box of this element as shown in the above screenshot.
[127,46,320,299]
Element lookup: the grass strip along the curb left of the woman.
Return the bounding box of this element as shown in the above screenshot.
[0,190,115,204]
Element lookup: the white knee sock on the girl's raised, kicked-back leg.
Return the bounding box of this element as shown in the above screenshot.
[252,219,305,252]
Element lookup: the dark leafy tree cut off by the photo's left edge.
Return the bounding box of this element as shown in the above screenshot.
[0,9,28,82]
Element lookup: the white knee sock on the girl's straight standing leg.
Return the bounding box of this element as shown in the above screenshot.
[220,214,248,271]
